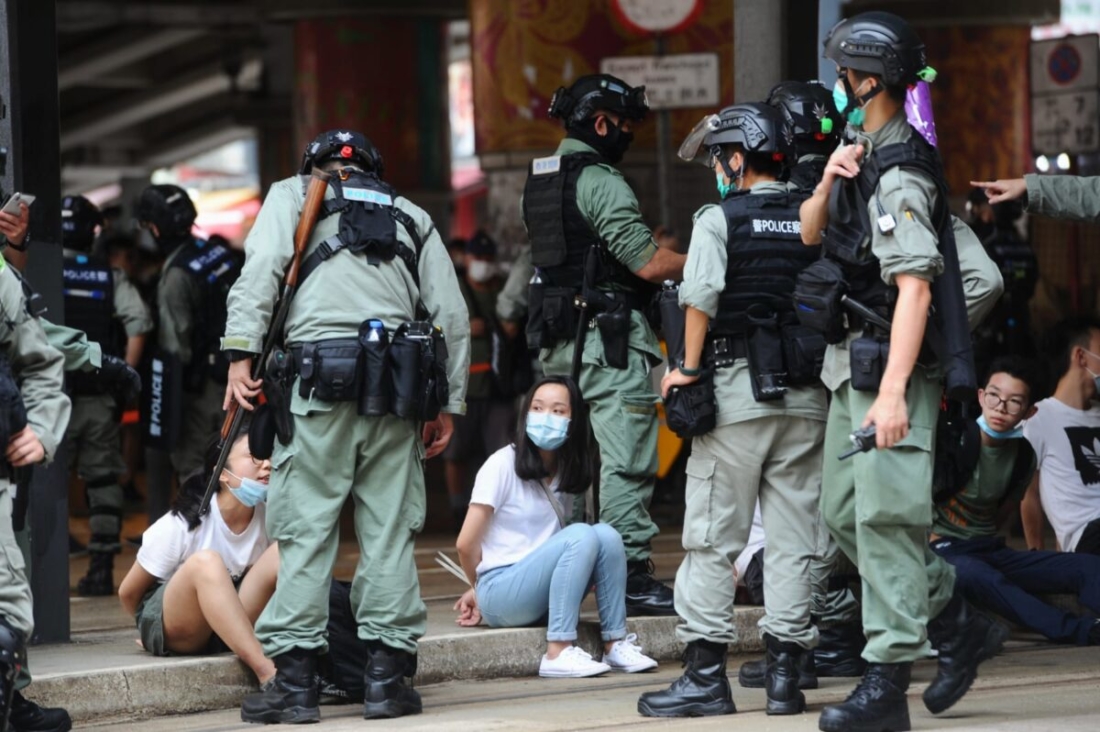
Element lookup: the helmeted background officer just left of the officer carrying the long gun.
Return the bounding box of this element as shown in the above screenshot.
[136,185,240,481]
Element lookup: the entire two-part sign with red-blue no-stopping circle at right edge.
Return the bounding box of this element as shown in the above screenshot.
[1031,33,1100,155]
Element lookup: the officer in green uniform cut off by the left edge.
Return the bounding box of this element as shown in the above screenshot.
[0,208,73,732]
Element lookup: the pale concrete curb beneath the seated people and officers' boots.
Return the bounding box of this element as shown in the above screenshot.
[28,608,763,722]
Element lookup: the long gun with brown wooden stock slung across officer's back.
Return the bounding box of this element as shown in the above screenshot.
[199,167,331,515]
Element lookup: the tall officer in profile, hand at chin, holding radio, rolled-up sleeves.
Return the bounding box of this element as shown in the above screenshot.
[796,12,1005,732]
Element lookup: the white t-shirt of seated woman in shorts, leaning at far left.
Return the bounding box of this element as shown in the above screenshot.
[138,496,271,582]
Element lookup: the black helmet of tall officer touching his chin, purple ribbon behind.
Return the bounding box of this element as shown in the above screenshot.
[824,11,926,87]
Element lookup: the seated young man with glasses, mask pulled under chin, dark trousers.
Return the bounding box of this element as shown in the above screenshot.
[932,357,1100,645]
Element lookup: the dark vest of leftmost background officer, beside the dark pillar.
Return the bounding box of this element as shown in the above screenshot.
[62,254,124,357]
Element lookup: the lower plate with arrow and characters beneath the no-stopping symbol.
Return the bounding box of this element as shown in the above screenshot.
[1032,89,1100,155]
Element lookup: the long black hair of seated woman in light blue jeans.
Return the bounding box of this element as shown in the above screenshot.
[516,376,592,493]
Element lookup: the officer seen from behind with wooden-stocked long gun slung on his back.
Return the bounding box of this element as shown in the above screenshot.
[222,130,470,723]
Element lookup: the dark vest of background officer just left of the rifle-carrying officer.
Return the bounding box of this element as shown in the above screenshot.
[172,239,242,391]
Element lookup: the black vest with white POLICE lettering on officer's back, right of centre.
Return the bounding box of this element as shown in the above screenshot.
[711,190,820,335]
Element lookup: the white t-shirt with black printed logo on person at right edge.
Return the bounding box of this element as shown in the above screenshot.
[1024,397,1100,551]
